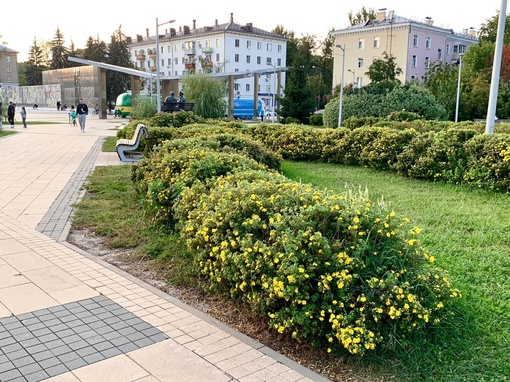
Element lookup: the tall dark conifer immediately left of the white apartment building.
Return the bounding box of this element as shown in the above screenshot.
[106,26,134,100]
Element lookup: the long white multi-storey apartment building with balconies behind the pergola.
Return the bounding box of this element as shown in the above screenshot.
[128,13,287,102]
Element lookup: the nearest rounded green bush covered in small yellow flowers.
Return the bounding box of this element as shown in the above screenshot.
[175,171,460,355]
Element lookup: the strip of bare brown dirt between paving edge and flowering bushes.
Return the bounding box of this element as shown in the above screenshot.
[67,230,378,382]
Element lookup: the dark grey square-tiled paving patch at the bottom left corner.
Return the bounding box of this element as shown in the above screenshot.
[0,296,169,382]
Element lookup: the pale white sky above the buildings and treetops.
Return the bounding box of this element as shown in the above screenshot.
[0,0,509,62]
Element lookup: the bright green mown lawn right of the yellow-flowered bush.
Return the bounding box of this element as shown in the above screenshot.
[283,162,510,382]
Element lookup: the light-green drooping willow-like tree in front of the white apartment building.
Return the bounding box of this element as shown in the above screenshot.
[182,73,226,118]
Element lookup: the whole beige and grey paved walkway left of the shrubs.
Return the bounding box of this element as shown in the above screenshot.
[0,110,327,382]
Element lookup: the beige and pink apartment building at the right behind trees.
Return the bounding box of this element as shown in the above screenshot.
[333,9,478,87]
